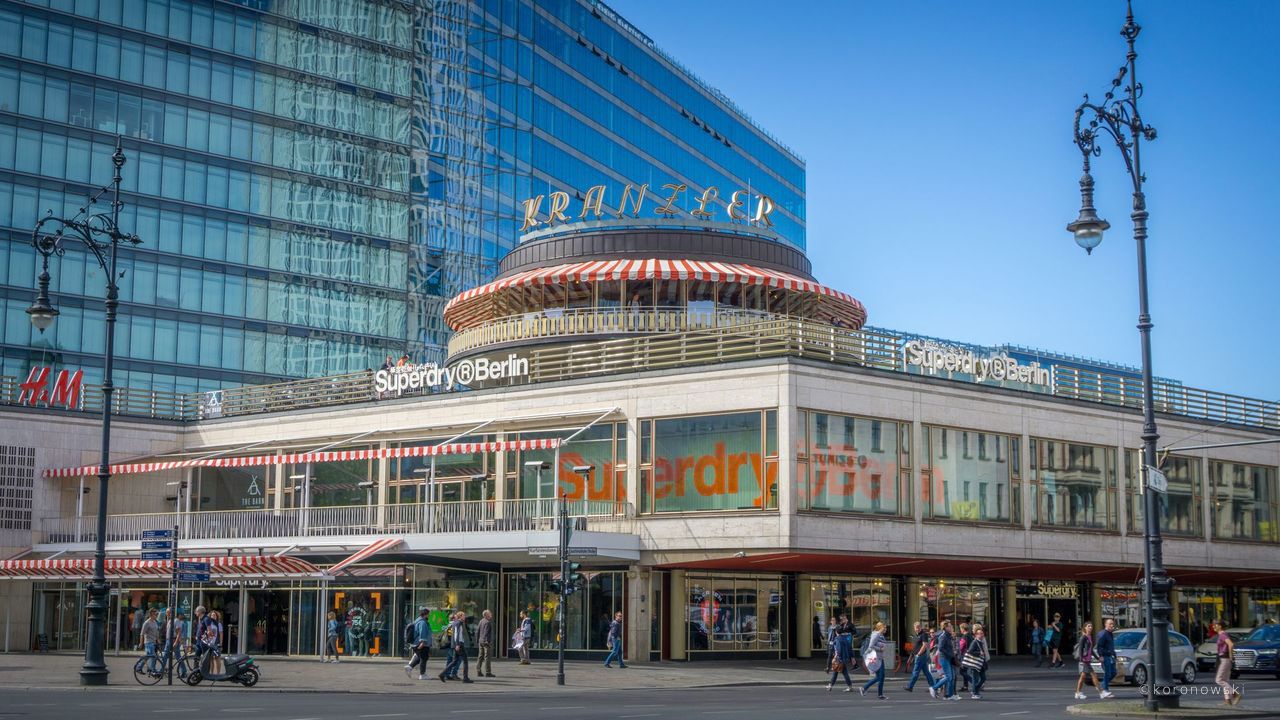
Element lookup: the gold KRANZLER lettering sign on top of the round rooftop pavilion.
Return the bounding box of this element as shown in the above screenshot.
[520,182,774,232]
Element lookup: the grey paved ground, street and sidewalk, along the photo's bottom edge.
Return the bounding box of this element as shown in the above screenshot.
[0,656,1280,720]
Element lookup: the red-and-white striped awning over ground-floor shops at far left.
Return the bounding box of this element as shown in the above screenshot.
[0,555,324,580]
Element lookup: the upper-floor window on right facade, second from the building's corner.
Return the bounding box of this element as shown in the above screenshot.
[922,425,1021,524]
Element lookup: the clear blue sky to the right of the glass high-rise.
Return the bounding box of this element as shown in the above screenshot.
[611,0,1280,400]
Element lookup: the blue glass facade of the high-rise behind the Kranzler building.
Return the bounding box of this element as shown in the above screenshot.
[0,0,805,392]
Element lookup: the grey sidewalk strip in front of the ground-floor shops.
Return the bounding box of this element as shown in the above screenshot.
[0,653,1080,693]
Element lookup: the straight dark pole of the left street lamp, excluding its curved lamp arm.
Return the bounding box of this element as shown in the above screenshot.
[81,140,124,685]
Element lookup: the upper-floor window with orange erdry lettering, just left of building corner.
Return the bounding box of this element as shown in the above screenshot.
[641,411,778,512]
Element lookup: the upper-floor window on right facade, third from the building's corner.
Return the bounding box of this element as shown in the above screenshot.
[1030,438,1116,530]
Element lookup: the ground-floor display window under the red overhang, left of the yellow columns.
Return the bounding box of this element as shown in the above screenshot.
[685,575,786,652]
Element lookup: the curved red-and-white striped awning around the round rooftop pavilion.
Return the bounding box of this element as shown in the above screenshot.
[444,259,867,329]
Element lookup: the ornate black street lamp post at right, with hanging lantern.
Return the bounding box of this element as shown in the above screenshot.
[1066,3,1179,711]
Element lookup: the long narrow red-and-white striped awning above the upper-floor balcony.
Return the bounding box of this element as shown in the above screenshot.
[44,438,561,478]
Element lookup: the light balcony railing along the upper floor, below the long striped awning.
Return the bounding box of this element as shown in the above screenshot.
[41,500,635,547]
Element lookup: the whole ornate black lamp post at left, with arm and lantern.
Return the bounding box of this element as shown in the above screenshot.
[27,140,142,685]
